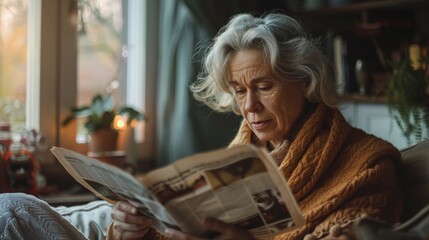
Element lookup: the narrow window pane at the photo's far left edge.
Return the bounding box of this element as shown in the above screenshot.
[0,0,28,132]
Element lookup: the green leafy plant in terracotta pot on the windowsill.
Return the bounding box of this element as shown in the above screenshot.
[63,94,144,152]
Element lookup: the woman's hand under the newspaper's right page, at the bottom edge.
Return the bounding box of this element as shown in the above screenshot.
[168,218,255,240]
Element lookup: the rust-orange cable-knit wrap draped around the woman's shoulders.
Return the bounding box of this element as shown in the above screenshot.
[231,104,402,240]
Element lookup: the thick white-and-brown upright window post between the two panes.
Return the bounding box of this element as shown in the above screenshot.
[26,0,83,160]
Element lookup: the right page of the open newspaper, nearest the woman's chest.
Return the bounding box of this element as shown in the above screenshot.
[142,145,304,238]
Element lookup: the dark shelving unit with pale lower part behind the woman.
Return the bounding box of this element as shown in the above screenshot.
[285,0,429,148]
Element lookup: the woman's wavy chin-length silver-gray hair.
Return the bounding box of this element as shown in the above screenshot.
[191,13,339,114]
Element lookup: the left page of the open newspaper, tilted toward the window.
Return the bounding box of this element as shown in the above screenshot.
[51,147,177,233]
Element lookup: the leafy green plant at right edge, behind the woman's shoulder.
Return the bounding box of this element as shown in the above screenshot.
[387,45,429,144]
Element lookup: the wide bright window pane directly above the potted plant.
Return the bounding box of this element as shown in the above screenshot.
[77,0,146,148]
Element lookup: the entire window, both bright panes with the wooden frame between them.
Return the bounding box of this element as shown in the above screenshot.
[0,0,154,161]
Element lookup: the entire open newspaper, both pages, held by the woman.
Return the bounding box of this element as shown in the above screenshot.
[51,144,304,238]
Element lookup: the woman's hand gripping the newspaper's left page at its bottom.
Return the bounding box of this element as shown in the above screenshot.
[111,201,153,239]
